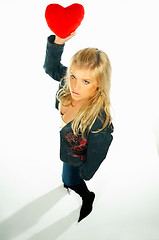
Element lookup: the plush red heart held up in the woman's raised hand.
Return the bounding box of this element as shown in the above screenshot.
[45,3,84,38]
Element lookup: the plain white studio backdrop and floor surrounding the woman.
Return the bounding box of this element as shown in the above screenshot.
[0,0,159,240]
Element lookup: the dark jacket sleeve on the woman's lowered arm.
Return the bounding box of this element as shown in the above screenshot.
[80,125,113,180]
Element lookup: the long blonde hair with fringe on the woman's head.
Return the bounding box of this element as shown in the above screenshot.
[57,48,112,136]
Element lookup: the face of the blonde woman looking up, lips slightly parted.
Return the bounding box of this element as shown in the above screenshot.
[70,65,98,101]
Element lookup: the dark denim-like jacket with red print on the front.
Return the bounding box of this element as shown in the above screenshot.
[44,35,113,180]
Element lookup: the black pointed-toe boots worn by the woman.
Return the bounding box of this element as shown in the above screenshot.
[64,180,95,222]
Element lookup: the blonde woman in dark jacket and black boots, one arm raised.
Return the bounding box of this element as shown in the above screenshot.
[44,33,113,222]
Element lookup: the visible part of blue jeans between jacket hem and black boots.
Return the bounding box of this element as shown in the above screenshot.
[62,163,82,187]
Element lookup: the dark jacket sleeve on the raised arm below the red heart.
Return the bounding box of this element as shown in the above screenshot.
[43,35,67,81]
